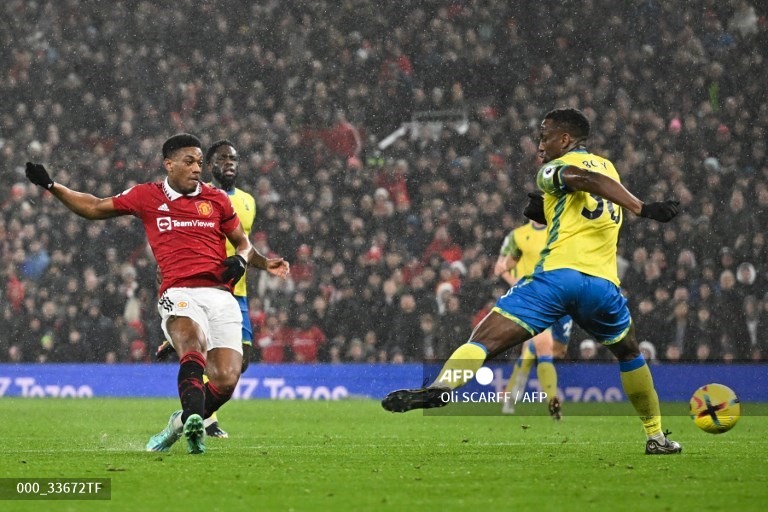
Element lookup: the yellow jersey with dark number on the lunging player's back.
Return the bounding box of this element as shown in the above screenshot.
[536,149,623,286]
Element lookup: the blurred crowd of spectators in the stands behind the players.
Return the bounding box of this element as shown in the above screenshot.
[0,0,768,362]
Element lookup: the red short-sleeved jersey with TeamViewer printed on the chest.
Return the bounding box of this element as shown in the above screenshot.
[112,181,240,295]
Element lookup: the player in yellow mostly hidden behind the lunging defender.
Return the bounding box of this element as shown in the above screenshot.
[494,220,573,420]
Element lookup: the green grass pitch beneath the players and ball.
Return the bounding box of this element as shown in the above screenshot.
[0,398,768,512]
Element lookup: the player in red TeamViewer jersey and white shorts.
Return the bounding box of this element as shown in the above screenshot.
[26,133,290,453]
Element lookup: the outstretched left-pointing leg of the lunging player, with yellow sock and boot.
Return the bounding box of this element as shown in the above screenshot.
[381,311,531,412]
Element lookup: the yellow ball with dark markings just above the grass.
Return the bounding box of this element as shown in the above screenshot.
[690,384,741,434]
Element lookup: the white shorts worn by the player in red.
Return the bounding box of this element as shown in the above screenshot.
[157,288,243,354]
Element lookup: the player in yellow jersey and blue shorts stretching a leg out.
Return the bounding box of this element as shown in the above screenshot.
[382,108,682,455]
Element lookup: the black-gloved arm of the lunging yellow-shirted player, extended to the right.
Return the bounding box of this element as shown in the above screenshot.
[560,166,680,222]
